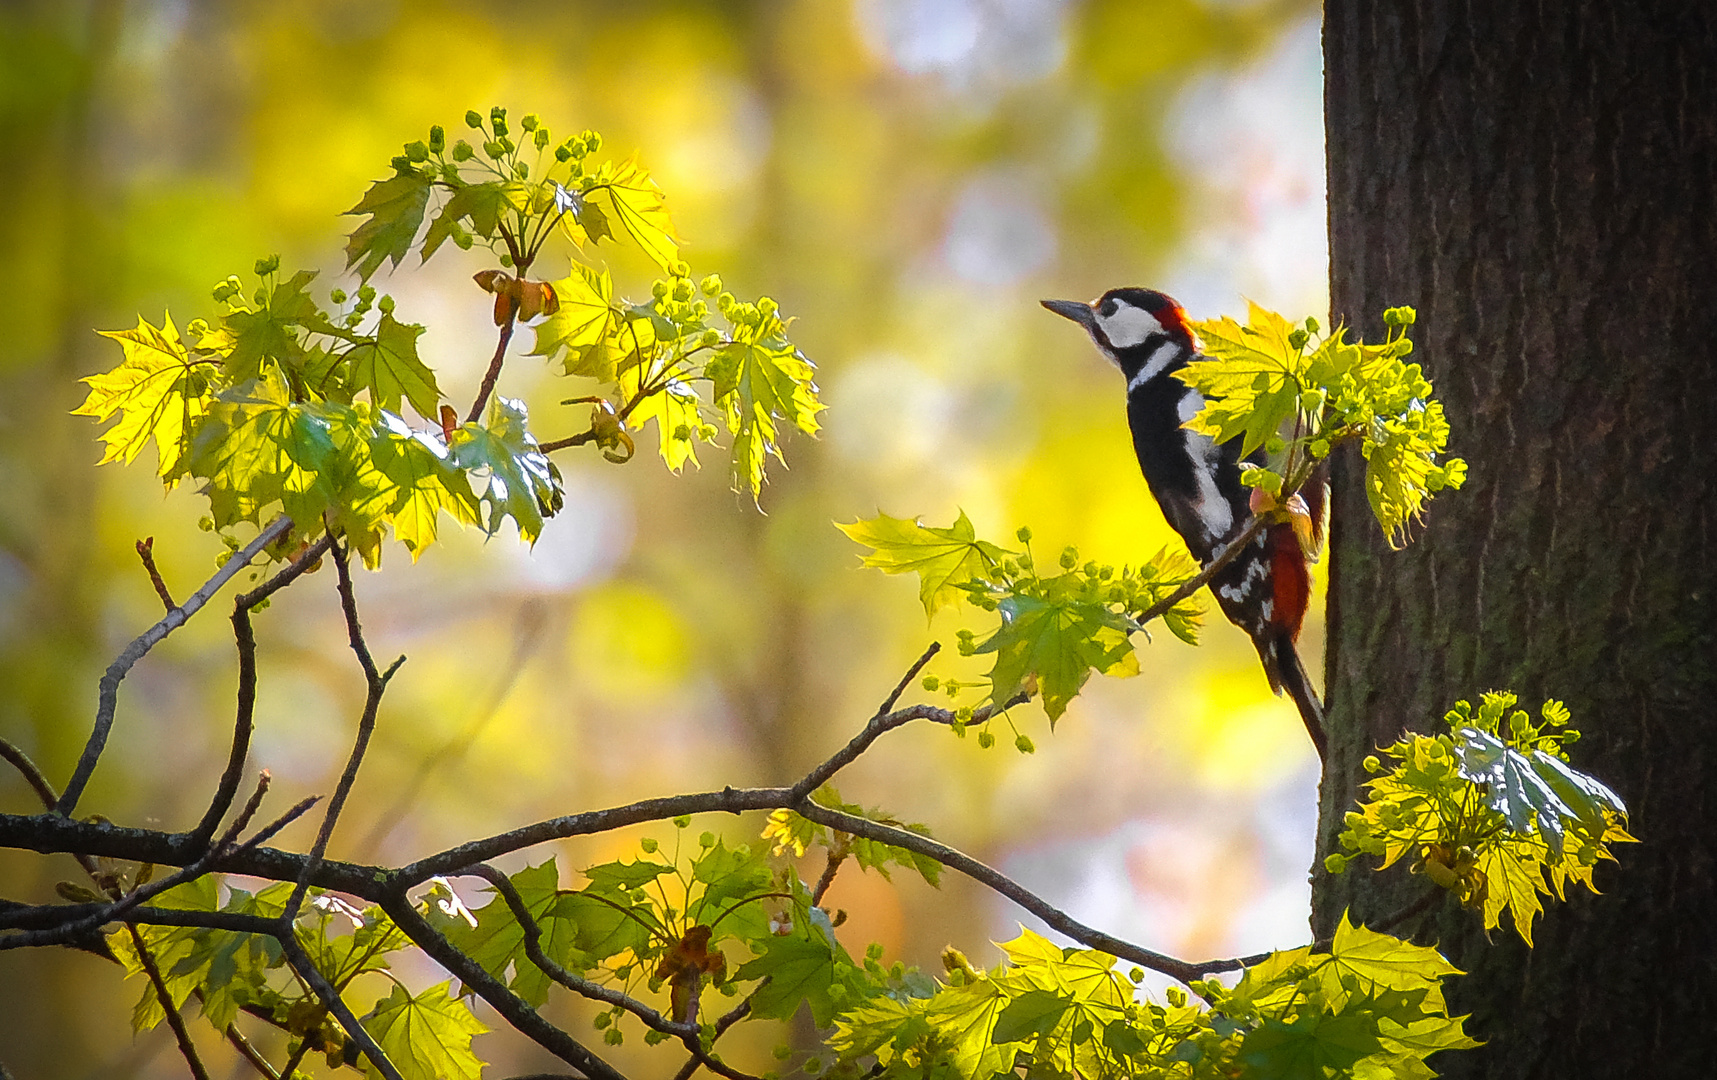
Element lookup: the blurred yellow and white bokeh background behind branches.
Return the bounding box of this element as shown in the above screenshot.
[0,0,1327,1080]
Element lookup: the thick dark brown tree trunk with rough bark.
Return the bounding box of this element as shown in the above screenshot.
[1314,0,1717,1077]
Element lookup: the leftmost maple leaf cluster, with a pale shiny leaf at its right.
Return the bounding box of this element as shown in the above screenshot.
[76,267,561,567]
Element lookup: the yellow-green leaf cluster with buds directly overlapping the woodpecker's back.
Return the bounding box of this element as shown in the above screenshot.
[1176,304,1466,546]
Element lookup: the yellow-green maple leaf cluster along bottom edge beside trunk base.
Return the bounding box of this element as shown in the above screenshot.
[831,917,1477,1080]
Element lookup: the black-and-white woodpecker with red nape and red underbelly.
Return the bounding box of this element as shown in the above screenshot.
[1044,288,1327,757]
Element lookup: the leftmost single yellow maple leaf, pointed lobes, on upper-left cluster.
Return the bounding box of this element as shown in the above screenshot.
[72,316,215,482]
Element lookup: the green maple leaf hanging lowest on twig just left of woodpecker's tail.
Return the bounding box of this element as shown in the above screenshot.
[975,579,1137,723]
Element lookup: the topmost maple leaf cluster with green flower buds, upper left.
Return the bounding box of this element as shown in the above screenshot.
[347,106,822,498]
